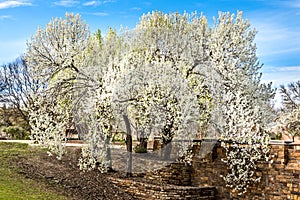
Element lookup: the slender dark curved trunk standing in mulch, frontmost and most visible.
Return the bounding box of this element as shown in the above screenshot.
[123,115,132,177]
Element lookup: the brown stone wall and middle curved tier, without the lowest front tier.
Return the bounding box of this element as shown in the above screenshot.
[145,142,300,200]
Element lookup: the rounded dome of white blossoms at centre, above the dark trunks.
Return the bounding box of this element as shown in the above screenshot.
[112,59,201,162]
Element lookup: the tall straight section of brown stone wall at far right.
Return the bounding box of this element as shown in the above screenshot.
[191,141,300,200]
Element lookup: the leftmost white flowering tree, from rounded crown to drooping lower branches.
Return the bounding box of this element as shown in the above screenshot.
[24,13,89,158]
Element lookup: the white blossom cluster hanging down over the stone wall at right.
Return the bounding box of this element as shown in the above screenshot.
[220,92,269,194]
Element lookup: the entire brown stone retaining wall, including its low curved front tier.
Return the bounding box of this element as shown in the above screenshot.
[112,142,300,200]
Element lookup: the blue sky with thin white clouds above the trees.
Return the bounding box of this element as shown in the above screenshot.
[0,0,300,89]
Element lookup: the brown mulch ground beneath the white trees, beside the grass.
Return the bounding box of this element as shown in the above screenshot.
[10,141,179,200]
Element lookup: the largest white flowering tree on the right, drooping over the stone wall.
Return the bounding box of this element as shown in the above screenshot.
[132,12,274,194]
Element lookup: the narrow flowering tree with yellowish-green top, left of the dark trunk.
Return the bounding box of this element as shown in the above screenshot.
[76,29,125,171]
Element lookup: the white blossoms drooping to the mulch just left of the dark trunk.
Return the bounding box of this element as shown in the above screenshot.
[73,84,112,172]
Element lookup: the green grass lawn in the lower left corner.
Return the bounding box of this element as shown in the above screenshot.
[0,141,67,200]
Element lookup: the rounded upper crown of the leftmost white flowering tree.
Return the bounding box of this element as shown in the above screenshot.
[25,13,89,81]
